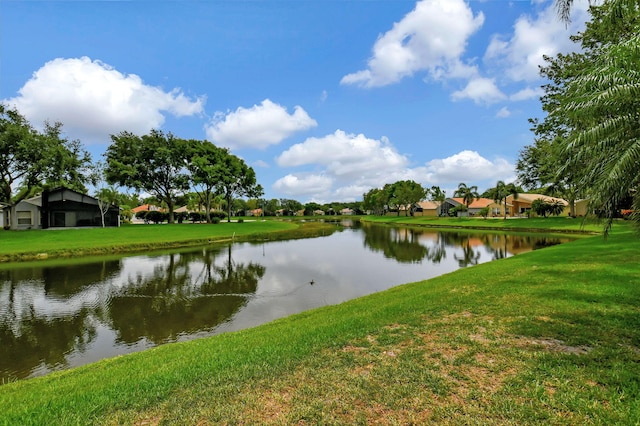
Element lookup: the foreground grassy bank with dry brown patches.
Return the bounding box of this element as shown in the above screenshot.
[0,218,640,425]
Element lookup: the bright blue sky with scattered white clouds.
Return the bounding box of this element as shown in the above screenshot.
[0,0,588,203]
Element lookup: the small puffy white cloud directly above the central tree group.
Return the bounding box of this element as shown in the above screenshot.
[205,99,318,149]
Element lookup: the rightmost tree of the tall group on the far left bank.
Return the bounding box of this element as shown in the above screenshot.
[216,151,263,222]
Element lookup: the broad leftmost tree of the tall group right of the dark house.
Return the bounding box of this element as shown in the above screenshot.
[105,130,189,223]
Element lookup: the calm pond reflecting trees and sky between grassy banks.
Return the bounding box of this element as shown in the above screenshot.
[0,222,571,383]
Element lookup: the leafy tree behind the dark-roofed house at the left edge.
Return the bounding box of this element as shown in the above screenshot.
[0,104,90,226]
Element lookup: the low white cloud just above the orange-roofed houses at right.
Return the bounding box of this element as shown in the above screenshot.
[427,150,514,186]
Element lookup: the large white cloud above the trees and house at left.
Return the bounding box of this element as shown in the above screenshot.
[5,57,205,143]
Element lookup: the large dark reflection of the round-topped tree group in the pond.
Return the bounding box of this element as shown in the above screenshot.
[109,246,265,344]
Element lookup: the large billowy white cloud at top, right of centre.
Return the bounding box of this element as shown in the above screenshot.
[341,0,484,87]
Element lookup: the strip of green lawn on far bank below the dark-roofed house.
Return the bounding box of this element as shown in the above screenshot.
[0,221,299,262]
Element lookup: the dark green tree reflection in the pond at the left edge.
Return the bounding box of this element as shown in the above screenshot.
[0,260,120,379]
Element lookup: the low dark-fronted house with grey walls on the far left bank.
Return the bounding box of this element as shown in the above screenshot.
[2,188,120,229]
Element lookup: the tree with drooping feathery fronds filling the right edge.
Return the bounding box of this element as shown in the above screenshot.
[545,0,640,234]
